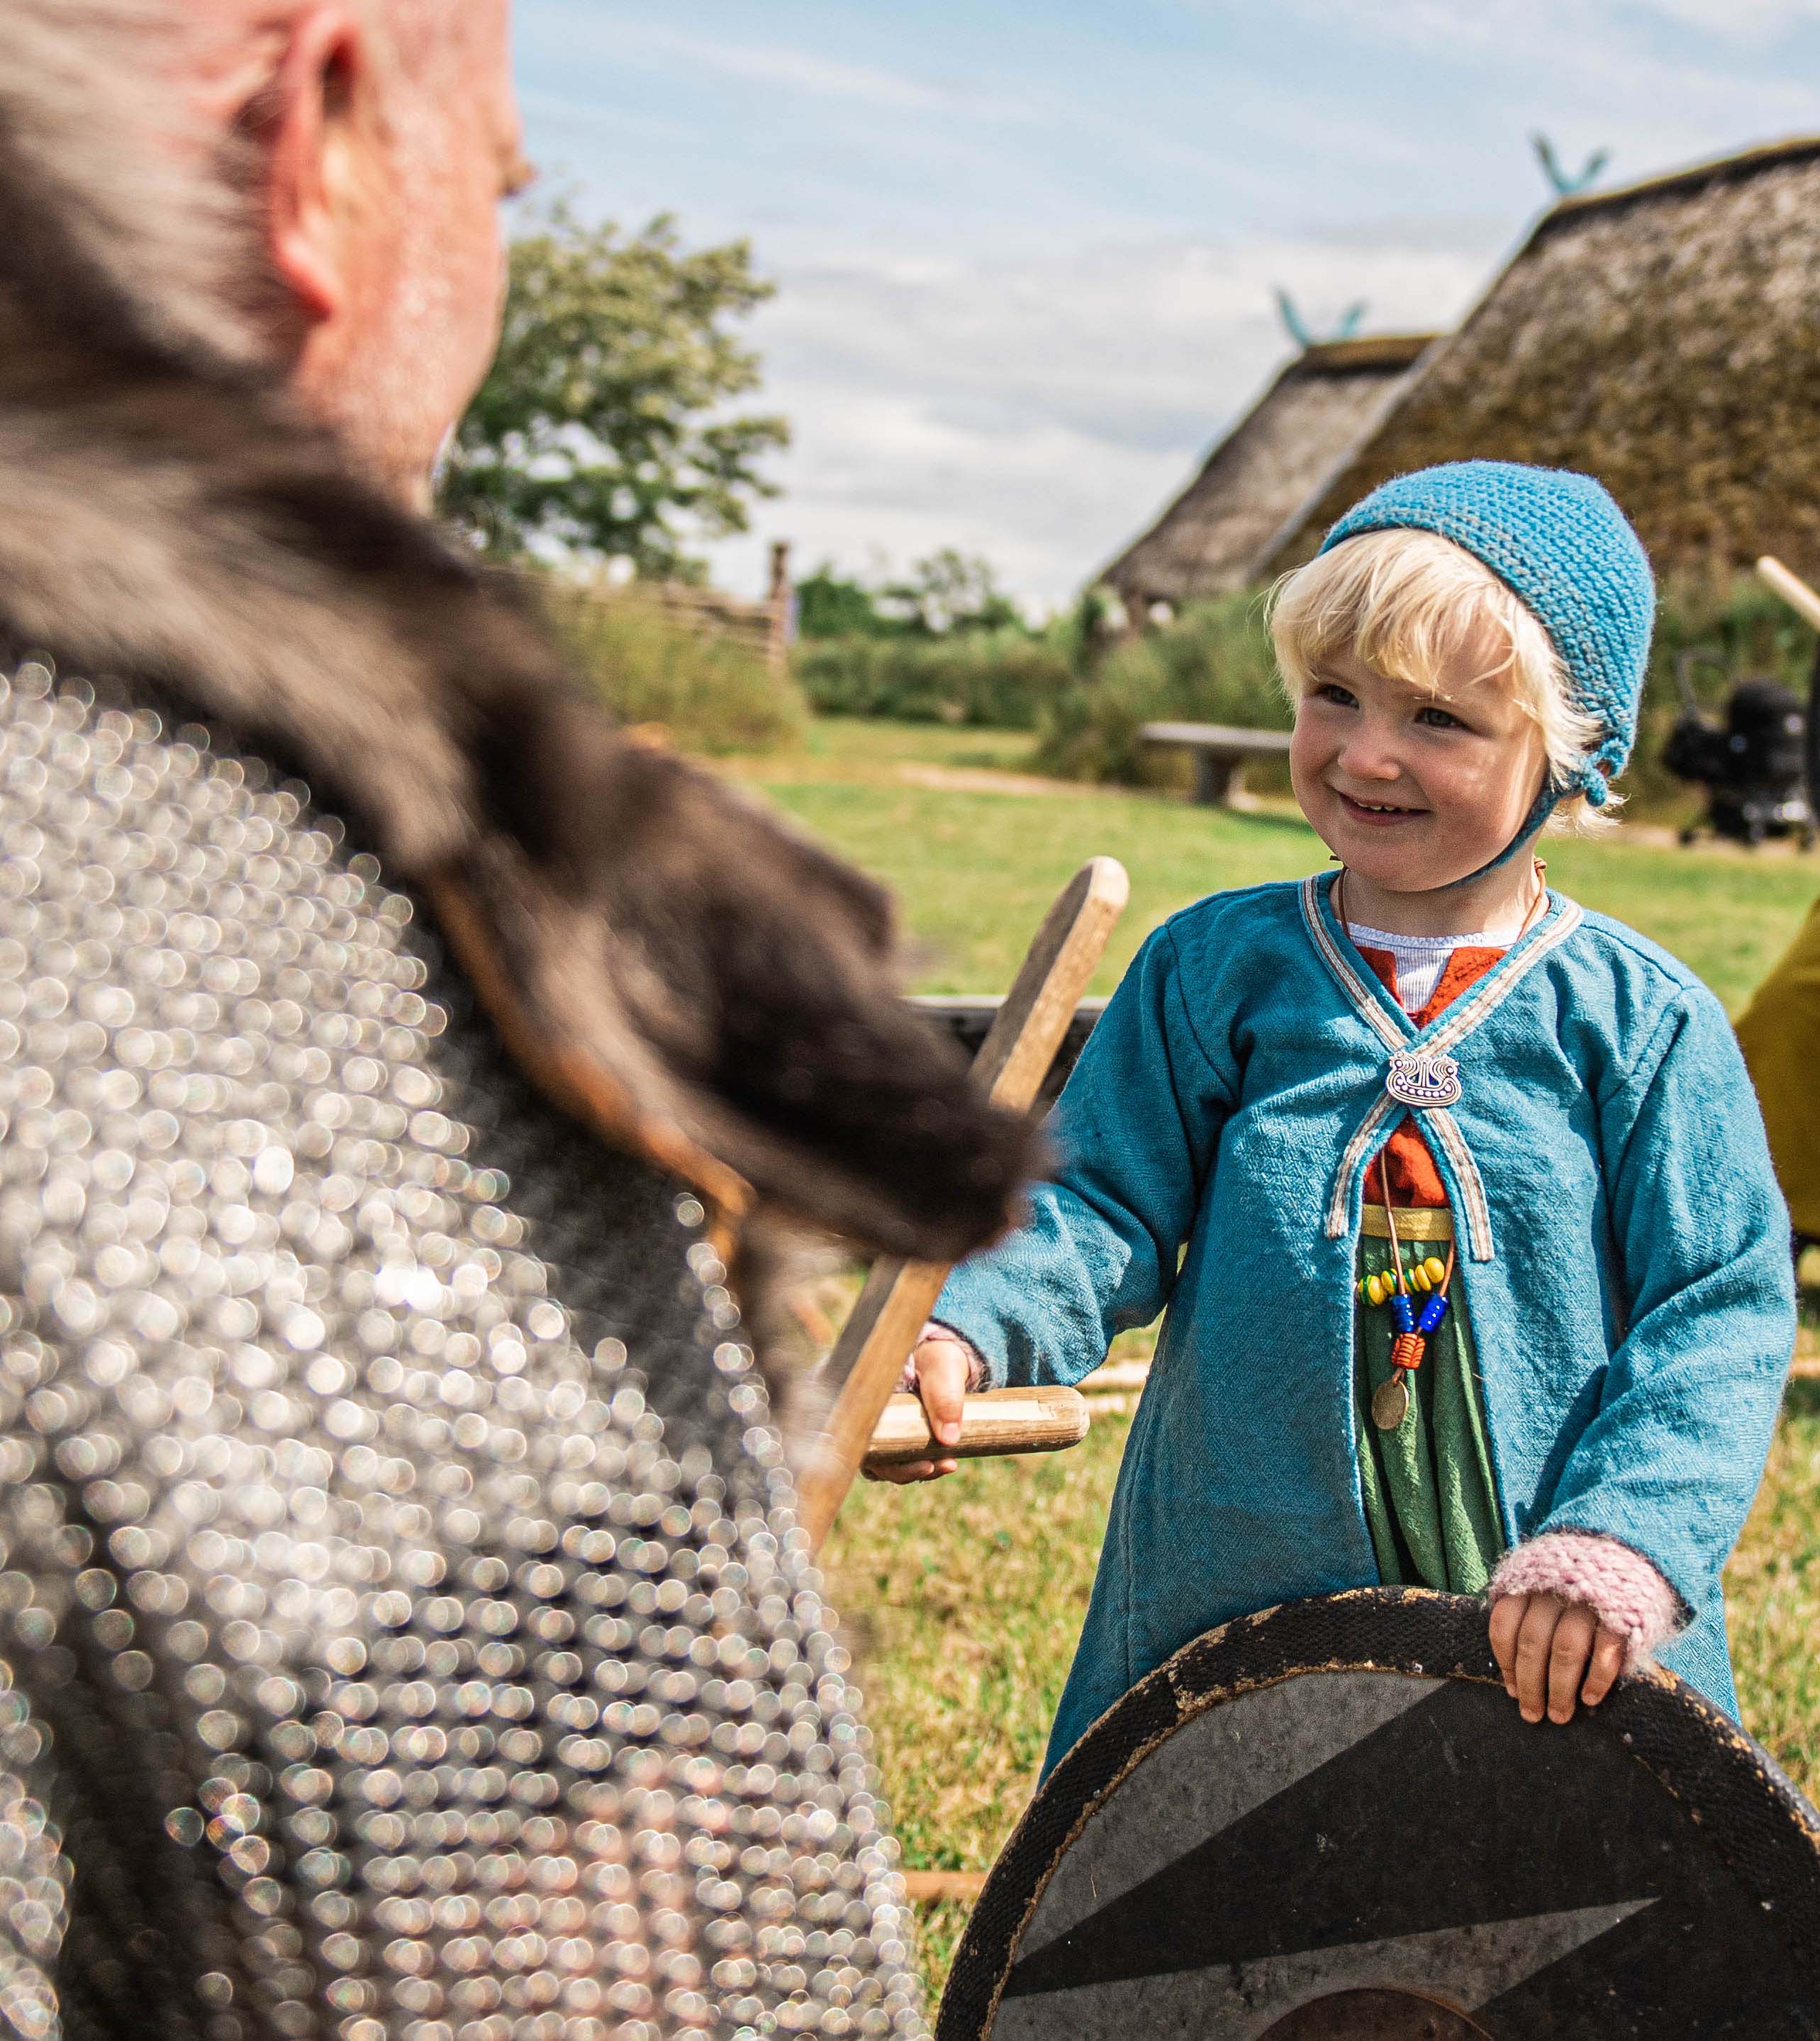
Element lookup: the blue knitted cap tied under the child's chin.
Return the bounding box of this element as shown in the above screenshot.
[1322,461,1655,845]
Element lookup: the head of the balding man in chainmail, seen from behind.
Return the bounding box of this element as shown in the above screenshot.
[25,0,525,498]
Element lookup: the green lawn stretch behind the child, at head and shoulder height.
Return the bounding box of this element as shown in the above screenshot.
[739,718,1820,1011]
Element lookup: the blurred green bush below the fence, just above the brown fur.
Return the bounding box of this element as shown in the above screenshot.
[547,586,808,753]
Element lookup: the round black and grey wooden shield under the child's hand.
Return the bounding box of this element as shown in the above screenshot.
[937,1588,1820,2041]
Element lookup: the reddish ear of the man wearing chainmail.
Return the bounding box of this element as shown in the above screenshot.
[265,0,369,325]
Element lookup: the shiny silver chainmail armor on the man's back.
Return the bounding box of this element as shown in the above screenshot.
[0,665,922,2041]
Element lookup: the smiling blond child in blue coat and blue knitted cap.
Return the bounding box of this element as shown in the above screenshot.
[893,461,1794,1765]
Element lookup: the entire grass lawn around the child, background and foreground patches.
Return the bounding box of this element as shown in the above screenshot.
[730,723,1820,1996]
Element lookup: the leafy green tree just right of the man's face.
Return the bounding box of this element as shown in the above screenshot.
[441,204,790,577]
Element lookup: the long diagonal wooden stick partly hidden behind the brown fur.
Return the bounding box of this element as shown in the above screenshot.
[798,857,1130,1547]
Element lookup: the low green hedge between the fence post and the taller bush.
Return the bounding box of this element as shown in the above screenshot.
[795,630,1073,730]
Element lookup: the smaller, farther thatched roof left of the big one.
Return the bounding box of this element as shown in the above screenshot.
[1100,333,1434,616]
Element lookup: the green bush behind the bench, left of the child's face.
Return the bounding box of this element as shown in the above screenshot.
[1037,594,1290,788]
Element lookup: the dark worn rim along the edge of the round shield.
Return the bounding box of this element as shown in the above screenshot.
[934,1588,1820,2041]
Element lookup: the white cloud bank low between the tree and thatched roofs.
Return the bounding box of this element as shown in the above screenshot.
[701,223,1500,604]
